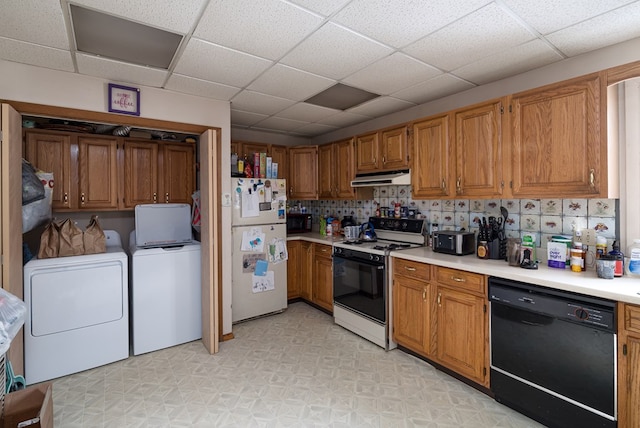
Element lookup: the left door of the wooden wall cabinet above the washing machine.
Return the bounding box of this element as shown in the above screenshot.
[124,140,158,208]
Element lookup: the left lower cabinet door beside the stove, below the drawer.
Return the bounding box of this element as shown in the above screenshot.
[393,275,431,356]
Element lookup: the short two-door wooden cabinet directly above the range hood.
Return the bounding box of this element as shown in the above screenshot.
[356,125,409,173]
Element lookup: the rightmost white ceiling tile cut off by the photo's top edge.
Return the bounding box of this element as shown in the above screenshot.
[502,0,633,35]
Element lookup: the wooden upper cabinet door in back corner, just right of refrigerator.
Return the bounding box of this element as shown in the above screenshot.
[289,146,318,199]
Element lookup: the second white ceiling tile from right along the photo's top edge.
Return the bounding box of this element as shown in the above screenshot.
[334,0,490,48]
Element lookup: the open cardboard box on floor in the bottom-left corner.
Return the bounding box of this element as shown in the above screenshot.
[2,382,53,428]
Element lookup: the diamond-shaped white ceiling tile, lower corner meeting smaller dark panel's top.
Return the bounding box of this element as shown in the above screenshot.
[282,23,392,79]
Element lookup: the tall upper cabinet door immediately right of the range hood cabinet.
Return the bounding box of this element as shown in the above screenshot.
[411,115,455,198]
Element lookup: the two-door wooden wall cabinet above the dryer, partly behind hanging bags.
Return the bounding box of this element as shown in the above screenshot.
[25,130,119,211]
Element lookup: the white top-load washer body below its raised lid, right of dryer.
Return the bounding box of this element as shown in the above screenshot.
[129,230,202,355]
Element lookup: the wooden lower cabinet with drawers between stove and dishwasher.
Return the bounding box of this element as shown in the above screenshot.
[393,259,489,388]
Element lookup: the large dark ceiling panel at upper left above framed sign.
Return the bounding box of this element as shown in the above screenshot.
[70,4,182,69]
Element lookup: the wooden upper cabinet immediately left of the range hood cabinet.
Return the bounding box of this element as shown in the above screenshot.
[318,138,356,199]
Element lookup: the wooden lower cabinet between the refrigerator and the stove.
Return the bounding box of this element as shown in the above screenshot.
[287,240,333,312]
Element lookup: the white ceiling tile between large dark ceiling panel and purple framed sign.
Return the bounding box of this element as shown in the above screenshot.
[76,53,167,87]
